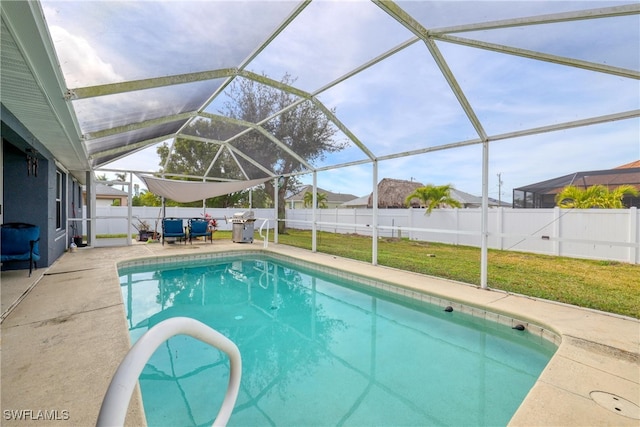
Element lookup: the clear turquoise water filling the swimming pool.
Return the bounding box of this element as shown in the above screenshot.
[120,255,556,426]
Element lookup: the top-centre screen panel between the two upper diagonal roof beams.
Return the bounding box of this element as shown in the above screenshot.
[248,1,410,95]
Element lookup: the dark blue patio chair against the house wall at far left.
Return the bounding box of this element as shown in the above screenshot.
[0,222,40,277]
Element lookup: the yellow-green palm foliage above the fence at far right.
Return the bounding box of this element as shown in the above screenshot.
[556,185,638,209]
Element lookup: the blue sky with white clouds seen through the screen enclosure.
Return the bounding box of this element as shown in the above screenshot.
[43,1,640,200]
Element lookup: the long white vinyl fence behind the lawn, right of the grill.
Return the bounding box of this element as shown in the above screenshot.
[287,208,640,264]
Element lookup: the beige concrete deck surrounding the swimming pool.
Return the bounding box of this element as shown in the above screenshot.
[0,241,640,427]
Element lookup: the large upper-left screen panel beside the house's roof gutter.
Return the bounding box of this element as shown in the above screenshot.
[42,0,295,88]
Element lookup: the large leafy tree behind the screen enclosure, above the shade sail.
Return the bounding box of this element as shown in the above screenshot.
[158,74,347,233]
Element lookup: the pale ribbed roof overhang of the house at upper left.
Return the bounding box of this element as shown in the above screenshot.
[0,1,90,182]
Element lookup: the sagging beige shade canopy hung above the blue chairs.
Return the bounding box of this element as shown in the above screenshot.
[138,174,268,203]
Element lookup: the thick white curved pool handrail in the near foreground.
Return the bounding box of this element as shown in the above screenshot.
[96,317,242,427]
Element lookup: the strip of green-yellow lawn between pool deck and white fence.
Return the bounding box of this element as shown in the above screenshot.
[215,230,640,318]
